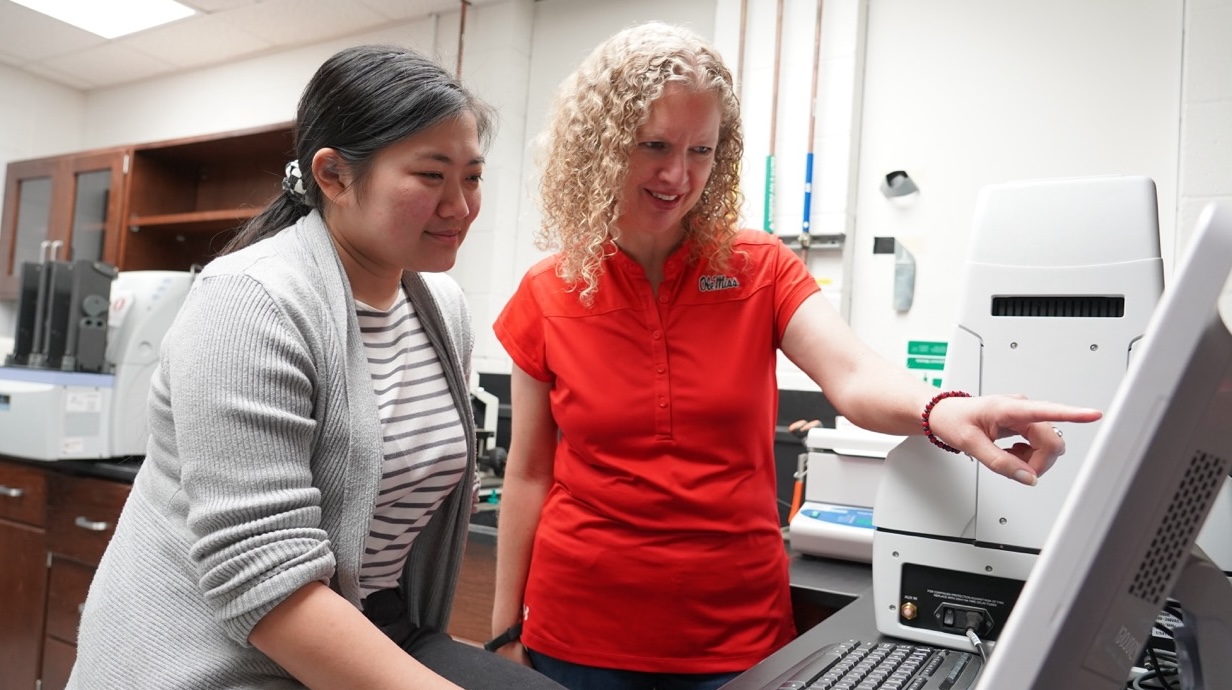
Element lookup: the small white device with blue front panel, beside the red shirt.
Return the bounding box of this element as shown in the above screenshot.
[787,416,903,563]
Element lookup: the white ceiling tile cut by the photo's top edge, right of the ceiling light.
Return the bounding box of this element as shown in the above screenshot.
[216,0,387,46]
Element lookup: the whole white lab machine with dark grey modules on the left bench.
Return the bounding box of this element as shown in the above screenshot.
[0,261,195,461]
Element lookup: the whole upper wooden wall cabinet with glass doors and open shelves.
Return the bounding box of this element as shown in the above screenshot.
[0,124,294,299]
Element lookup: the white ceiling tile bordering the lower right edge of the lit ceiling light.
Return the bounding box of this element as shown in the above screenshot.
[116,15,271,68]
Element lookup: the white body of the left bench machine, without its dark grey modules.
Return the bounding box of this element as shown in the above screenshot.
[0,271,195,461]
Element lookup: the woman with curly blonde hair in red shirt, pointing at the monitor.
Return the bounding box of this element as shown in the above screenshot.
[488,22,1099,690]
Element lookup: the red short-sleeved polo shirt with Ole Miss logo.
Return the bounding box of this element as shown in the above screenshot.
[495,232,818,673]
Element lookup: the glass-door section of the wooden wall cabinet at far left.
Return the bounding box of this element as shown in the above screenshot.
[0,148,127,299]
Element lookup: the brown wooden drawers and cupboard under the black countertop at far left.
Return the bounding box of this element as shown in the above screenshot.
[0,462,131,690]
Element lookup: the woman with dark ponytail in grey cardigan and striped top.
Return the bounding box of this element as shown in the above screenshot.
[69,46,557,689]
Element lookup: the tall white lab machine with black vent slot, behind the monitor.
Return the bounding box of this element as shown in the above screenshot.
[872,176,1163,647]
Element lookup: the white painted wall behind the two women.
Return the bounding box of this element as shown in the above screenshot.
[0,0,1232,388]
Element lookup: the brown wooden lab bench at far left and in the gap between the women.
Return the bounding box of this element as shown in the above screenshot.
[0,455,496,690]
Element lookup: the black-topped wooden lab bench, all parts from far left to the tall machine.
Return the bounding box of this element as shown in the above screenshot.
[0,455,876,690]
